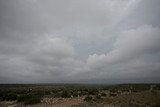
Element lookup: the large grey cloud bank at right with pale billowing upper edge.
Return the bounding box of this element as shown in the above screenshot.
[87,25,160,82]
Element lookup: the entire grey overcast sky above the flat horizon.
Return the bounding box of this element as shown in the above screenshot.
[0,0,160,84]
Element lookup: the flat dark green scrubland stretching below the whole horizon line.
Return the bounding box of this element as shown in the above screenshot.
[0,84,160,107]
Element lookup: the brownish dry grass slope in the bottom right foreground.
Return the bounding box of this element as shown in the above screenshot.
[75,91,160,107]
